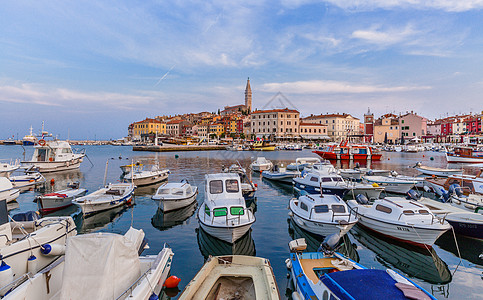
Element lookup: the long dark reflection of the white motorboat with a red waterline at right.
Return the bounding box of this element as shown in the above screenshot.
[351,225,452,284]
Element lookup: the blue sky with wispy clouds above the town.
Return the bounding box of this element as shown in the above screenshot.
[0,0,483,139]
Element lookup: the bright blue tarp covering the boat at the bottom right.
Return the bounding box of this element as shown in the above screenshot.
[321,269,429,300]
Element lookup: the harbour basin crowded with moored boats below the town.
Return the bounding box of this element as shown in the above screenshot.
[0,141,483,299]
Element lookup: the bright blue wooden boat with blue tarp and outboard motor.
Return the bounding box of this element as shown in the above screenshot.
[285,237,436,300]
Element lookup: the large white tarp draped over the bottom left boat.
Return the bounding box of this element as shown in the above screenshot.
[60,233,141,300]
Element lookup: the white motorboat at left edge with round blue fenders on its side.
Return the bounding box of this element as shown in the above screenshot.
[0,201,77,296]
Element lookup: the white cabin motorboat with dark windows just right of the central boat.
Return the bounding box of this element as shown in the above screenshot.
[289,195,357,237]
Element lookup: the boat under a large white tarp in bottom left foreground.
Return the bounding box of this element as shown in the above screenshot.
[4,228,174,300]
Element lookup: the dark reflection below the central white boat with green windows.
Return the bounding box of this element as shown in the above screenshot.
[196,227,256,259]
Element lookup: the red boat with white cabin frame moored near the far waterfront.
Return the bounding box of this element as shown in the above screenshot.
[313,141,382,161]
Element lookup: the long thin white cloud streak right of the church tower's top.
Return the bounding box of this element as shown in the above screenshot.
[262,80,431,94]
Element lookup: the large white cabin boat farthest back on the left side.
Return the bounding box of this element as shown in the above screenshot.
[22,139,86,173]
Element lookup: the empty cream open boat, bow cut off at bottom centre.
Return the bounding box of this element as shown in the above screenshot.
[178,255,280,300]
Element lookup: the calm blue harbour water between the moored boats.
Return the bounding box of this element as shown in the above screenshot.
[0,146,483,299]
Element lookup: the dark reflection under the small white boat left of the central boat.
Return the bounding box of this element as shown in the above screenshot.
[151,201,198,231]
